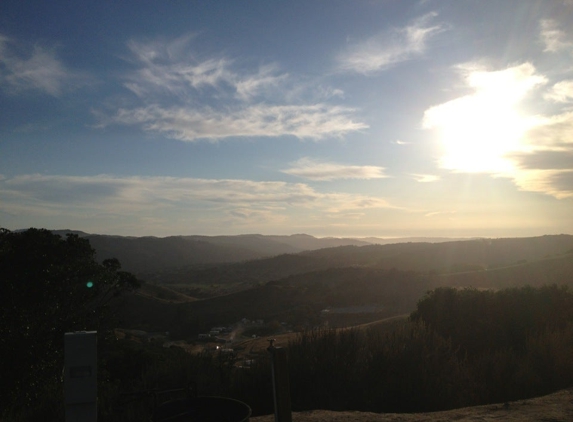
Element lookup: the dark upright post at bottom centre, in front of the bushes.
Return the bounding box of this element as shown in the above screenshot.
[267,339,292,422]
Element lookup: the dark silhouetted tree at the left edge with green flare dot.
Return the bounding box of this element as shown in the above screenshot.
[0,229,139,415]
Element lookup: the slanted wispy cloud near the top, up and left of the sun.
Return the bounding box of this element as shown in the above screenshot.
[338,12,444,74]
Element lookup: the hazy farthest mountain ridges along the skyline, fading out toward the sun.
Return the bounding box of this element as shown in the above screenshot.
[50,230,496,276]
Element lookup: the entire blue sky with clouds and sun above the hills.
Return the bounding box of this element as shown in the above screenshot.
[0,0,573,237]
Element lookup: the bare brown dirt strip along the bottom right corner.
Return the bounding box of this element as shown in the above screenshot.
[250,388,573,422]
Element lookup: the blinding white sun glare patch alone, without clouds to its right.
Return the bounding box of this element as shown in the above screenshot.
[424,64,544,174]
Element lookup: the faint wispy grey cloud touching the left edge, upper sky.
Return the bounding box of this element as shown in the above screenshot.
[0,35,82,97]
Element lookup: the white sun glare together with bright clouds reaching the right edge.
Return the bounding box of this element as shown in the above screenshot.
[423,63,573,199]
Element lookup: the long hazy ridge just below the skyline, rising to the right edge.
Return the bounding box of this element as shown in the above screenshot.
[144,235,573,296]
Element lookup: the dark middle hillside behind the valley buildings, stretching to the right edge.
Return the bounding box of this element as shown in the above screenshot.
[114,249,573,336]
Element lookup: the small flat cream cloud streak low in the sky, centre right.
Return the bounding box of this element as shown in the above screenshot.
[282,157,388,181]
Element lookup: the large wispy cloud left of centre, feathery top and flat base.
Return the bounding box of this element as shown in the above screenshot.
[102,36,368,141]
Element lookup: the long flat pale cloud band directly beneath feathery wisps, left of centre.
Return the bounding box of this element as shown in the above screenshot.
[113,104,368,141]
